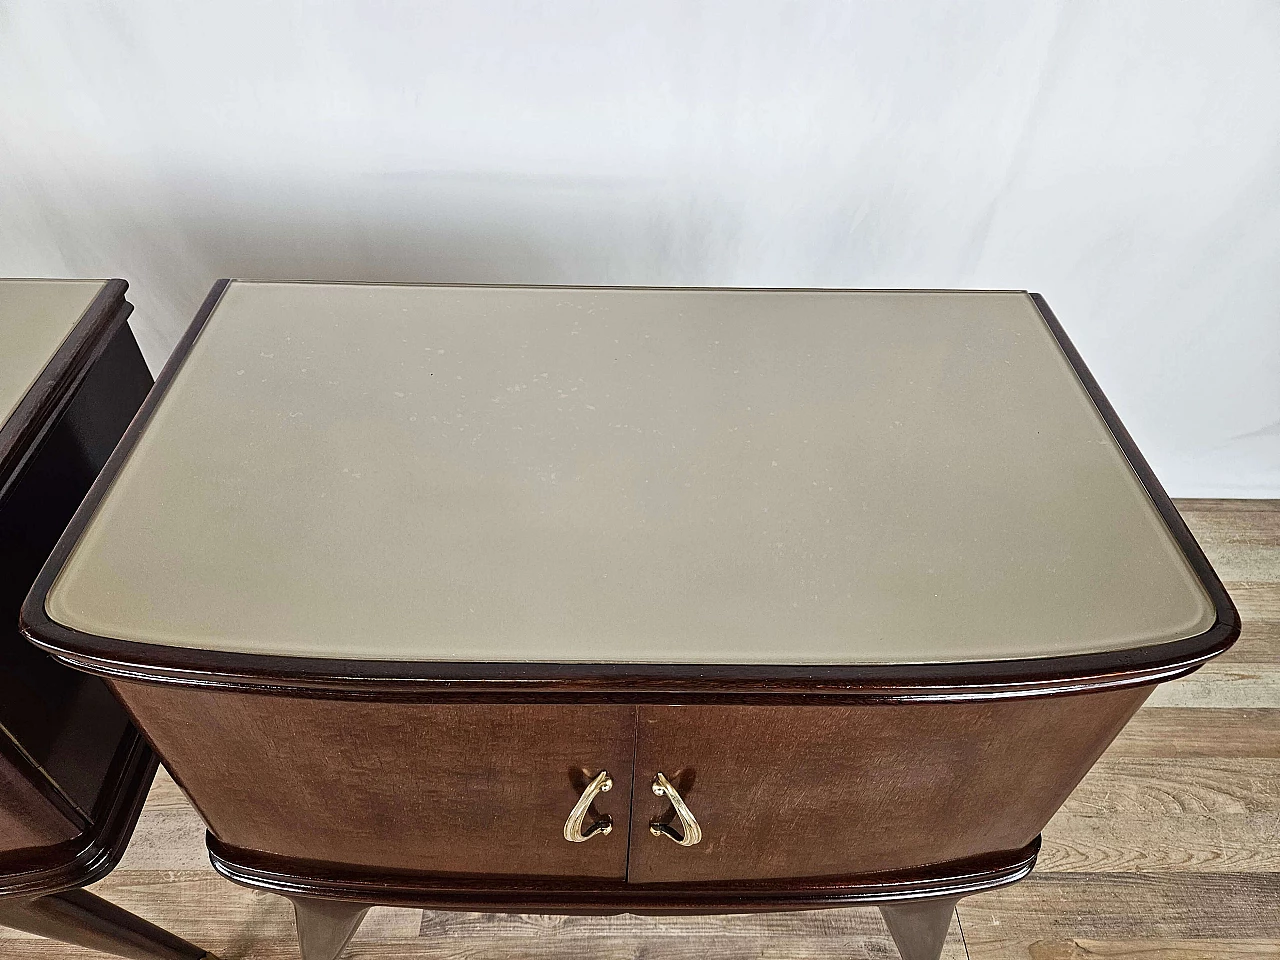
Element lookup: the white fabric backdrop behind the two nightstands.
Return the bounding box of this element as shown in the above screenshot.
[0,0,1280,497]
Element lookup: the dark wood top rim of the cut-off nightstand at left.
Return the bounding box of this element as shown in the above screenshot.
[0,279,133,500]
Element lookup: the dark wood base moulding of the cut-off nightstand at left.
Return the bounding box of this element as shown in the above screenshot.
[0,730,160,897]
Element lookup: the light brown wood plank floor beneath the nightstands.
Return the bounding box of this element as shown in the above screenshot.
[0,500,1280,960]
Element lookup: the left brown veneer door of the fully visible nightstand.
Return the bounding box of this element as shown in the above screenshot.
[107,682,635,879]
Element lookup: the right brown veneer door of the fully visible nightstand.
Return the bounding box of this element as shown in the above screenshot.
[627,687,1149,882]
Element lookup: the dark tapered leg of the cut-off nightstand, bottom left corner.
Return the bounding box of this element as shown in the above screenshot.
[0,890,218,960]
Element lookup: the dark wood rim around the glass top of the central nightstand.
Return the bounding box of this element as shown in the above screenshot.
[22,280,1239,703]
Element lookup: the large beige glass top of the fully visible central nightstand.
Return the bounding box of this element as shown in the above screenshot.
[47,283,1213,664]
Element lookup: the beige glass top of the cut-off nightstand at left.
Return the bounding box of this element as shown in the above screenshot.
[0,280,106,424]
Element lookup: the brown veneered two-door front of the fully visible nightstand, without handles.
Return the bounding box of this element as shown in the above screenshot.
[114,681,1149,883]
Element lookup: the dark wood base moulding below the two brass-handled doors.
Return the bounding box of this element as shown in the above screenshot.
[206,833,1041,913]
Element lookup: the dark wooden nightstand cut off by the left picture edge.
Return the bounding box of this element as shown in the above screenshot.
[0,280,217,960]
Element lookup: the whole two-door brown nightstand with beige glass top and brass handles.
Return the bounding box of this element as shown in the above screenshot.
[23,282,1239,960]
